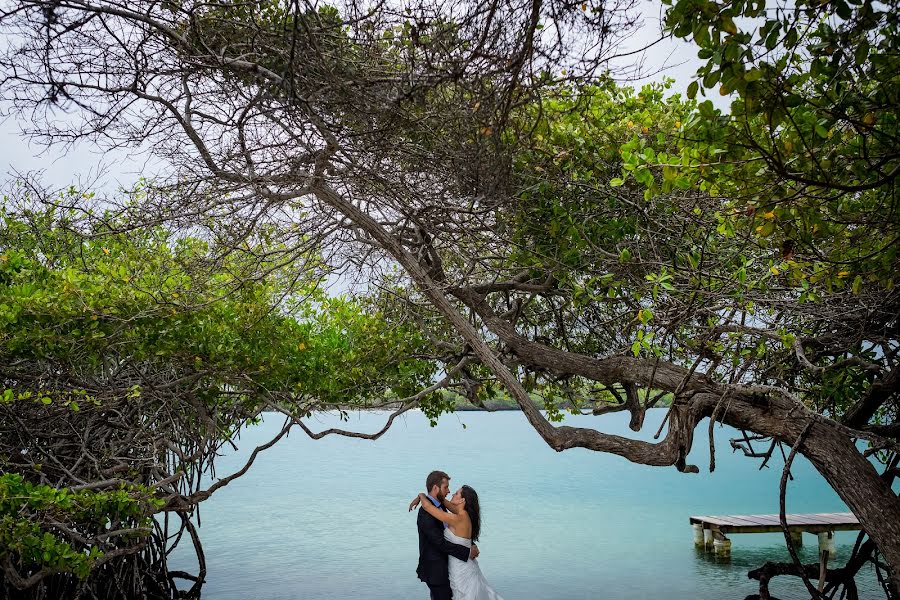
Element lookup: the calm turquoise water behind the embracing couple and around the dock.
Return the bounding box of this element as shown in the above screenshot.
[170,409,883,600]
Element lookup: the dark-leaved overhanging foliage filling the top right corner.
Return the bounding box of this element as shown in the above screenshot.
[652,1,900,288]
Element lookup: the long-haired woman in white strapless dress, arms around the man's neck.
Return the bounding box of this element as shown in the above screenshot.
[410,485,503,600]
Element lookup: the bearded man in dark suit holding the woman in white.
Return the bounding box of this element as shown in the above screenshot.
[416,471,478,600]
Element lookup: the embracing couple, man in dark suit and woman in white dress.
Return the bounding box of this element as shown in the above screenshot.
[409,471,503,600]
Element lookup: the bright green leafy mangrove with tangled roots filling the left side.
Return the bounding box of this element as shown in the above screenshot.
[0,198,433,597]
